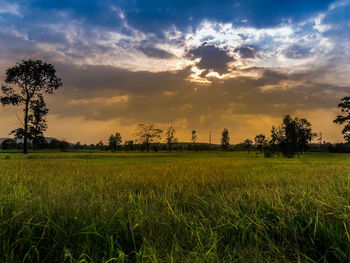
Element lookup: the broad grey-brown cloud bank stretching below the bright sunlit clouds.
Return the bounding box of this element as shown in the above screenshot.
[51,62,349,127]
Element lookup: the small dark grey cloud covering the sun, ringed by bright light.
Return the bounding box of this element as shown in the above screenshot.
[187,43,234,74]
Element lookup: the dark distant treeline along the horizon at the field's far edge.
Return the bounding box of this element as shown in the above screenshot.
[1,115,350,158]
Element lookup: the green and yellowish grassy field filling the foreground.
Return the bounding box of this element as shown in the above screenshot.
[0,153,350,262]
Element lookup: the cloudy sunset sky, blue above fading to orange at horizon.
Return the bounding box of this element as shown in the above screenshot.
[0,0,350,143]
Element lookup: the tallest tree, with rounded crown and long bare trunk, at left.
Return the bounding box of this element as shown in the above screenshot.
[0,60,62,154]
